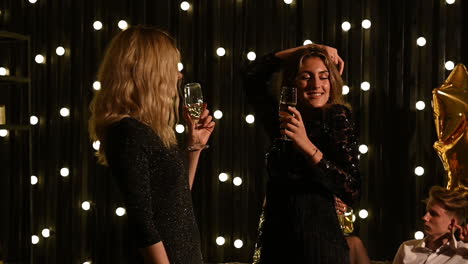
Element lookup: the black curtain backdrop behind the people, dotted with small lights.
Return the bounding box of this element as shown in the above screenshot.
[0,0,468,264]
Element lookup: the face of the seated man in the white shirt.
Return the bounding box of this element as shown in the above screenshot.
[422,202,456,239]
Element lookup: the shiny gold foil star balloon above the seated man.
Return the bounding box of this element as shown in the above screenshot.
[432,64,468,191]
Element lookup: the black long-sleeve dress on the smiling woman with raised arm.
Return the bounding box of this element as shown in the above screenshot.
[244,54,360,264]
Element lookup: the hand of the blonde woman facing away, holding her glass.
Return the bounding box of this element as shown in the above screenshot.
[184,103,216,151]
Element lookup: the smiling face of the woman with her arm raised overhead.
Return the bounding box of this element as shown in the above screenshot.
[296,57,331,108]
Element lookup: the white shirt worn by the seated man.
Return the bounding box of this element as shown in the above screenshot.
[393,236,468,264]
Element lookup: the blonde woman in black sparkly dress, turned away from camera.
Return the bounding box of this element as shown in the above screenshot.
[89,26,215,264]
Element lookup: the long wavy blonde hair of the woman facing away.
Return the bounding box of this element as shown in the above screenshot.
[89,26,180,164]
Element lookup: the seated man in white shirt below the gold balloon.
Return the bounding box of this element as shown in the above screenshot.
[393,186,468,264]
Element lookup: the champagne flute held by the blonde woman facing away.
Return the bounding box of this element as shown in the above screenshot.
[184,83,209,151]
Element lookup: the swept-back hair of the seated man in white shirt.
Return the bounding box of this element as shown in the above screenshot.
[426,186,468,224]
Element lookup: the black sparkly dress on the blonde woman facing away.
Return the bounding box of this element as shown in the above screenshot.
[104,118,202,264]
